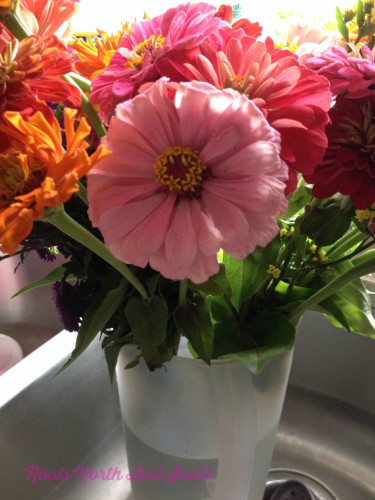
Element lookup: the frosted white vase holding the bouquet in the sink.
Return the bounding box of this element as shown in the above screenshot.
[116,346,292,500]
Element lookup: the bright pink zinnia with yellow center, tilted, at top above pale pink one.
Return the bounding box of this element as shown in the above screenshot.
[90,2,226,123]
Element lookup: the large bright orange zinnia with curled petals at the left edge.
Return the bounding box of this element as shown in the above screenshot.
[0,109,109,254]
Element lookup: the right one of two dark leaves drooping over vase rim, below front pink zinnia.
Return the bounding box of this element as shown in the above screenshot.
[174,296,214,364]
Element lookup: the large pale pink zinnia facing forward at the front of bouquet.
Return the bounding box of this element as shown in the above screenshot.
[88,79,287,283]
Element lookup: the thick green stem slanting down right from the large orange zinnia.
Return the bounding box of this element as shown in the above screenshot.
[45,205,149,300]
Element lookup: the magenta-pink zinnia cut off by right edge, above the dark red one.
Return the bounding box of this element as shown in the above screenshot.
[305,45,375,98]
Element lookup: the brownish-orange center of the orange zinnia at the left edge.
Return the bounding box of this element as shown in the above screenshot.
[0,154,45,203]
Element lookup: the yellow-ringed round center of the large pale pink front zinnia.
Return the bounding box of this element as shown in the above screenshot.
[154,146,207,197]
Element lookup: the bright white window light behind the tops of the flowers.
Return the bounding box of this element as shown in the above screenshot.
[72,0,351,32]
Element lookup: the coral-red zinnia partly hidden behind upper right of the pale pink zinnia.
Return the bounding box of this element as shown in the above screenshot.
[181,32,331,193]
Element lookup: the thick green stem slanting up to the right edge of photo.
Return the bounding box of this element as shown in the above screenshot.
[290,250,375,321]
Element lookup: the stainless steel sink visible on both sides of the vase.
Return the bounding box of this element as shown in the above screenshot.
[0,265,375,500]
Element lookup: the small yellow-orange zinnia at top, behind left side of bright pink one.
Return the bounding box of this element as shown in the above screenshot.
[69,23,130,80]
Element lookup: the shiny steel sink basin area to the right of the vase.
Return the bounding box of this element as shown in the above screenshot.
[269,314,375,500]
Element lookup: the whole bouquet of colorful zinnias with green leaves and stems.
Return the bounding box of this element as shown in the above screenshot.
[0,0,375,498]
